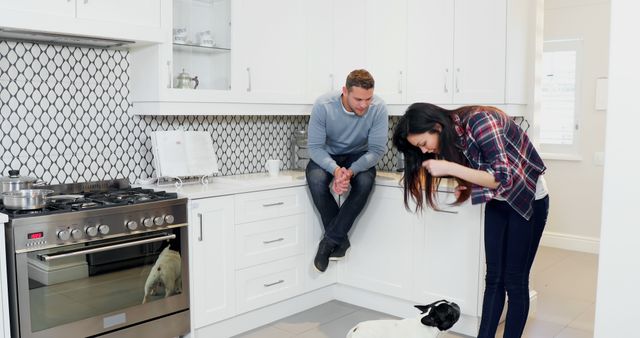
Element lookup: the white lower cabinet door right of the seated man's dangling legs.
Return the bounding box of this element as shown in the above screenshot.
[338,185,420,299]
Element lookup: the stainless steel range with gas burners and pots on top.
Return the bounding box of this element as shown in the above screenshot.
[0,180,190,338]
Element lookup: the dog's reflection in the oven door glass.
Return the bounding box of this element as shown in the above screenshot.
[142,246,182,304]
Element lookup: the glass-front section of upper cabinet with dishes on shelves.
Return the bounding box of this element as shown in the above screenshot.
[171,0,231,90]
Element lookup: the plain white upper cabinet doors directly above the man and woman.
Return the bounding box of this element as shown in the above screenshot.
[306,0,507,104]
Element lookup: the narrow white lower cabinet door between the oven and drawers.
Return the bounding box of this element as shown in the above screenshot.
[189,196,236,329]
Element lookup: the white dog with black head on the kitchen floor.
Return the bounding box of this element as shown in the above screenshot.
[347,300,460,338]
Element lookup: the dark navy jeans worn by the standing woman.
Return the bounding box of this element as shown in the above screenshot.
[478,196,549,338]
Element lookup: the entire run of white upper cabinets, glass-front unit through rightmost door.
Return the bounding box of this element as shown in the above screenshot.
[125,0,535,115]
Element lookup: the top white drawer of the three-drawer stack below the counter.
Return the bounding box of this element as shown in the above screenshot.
[235,187,307,224]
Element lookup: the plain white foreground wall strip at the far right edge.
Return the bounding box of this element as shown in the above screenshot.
[594,0,640,338]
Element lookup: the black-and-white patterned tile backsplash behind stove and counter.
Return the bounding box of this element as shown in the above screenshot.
[0,41,398,184]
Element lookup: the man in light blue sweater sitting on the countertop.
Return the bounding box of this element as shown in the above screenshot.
[306,69,389,272]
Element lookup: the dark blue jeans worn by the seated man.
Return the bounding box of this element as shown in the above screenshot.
[306,153,376,245]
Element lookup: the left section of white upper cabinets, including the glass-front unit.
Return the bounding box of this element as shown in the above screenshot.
[131,0,316,115]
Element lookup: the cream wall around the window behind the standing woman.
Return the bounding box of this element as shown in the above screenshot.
[542,0,609,252]
